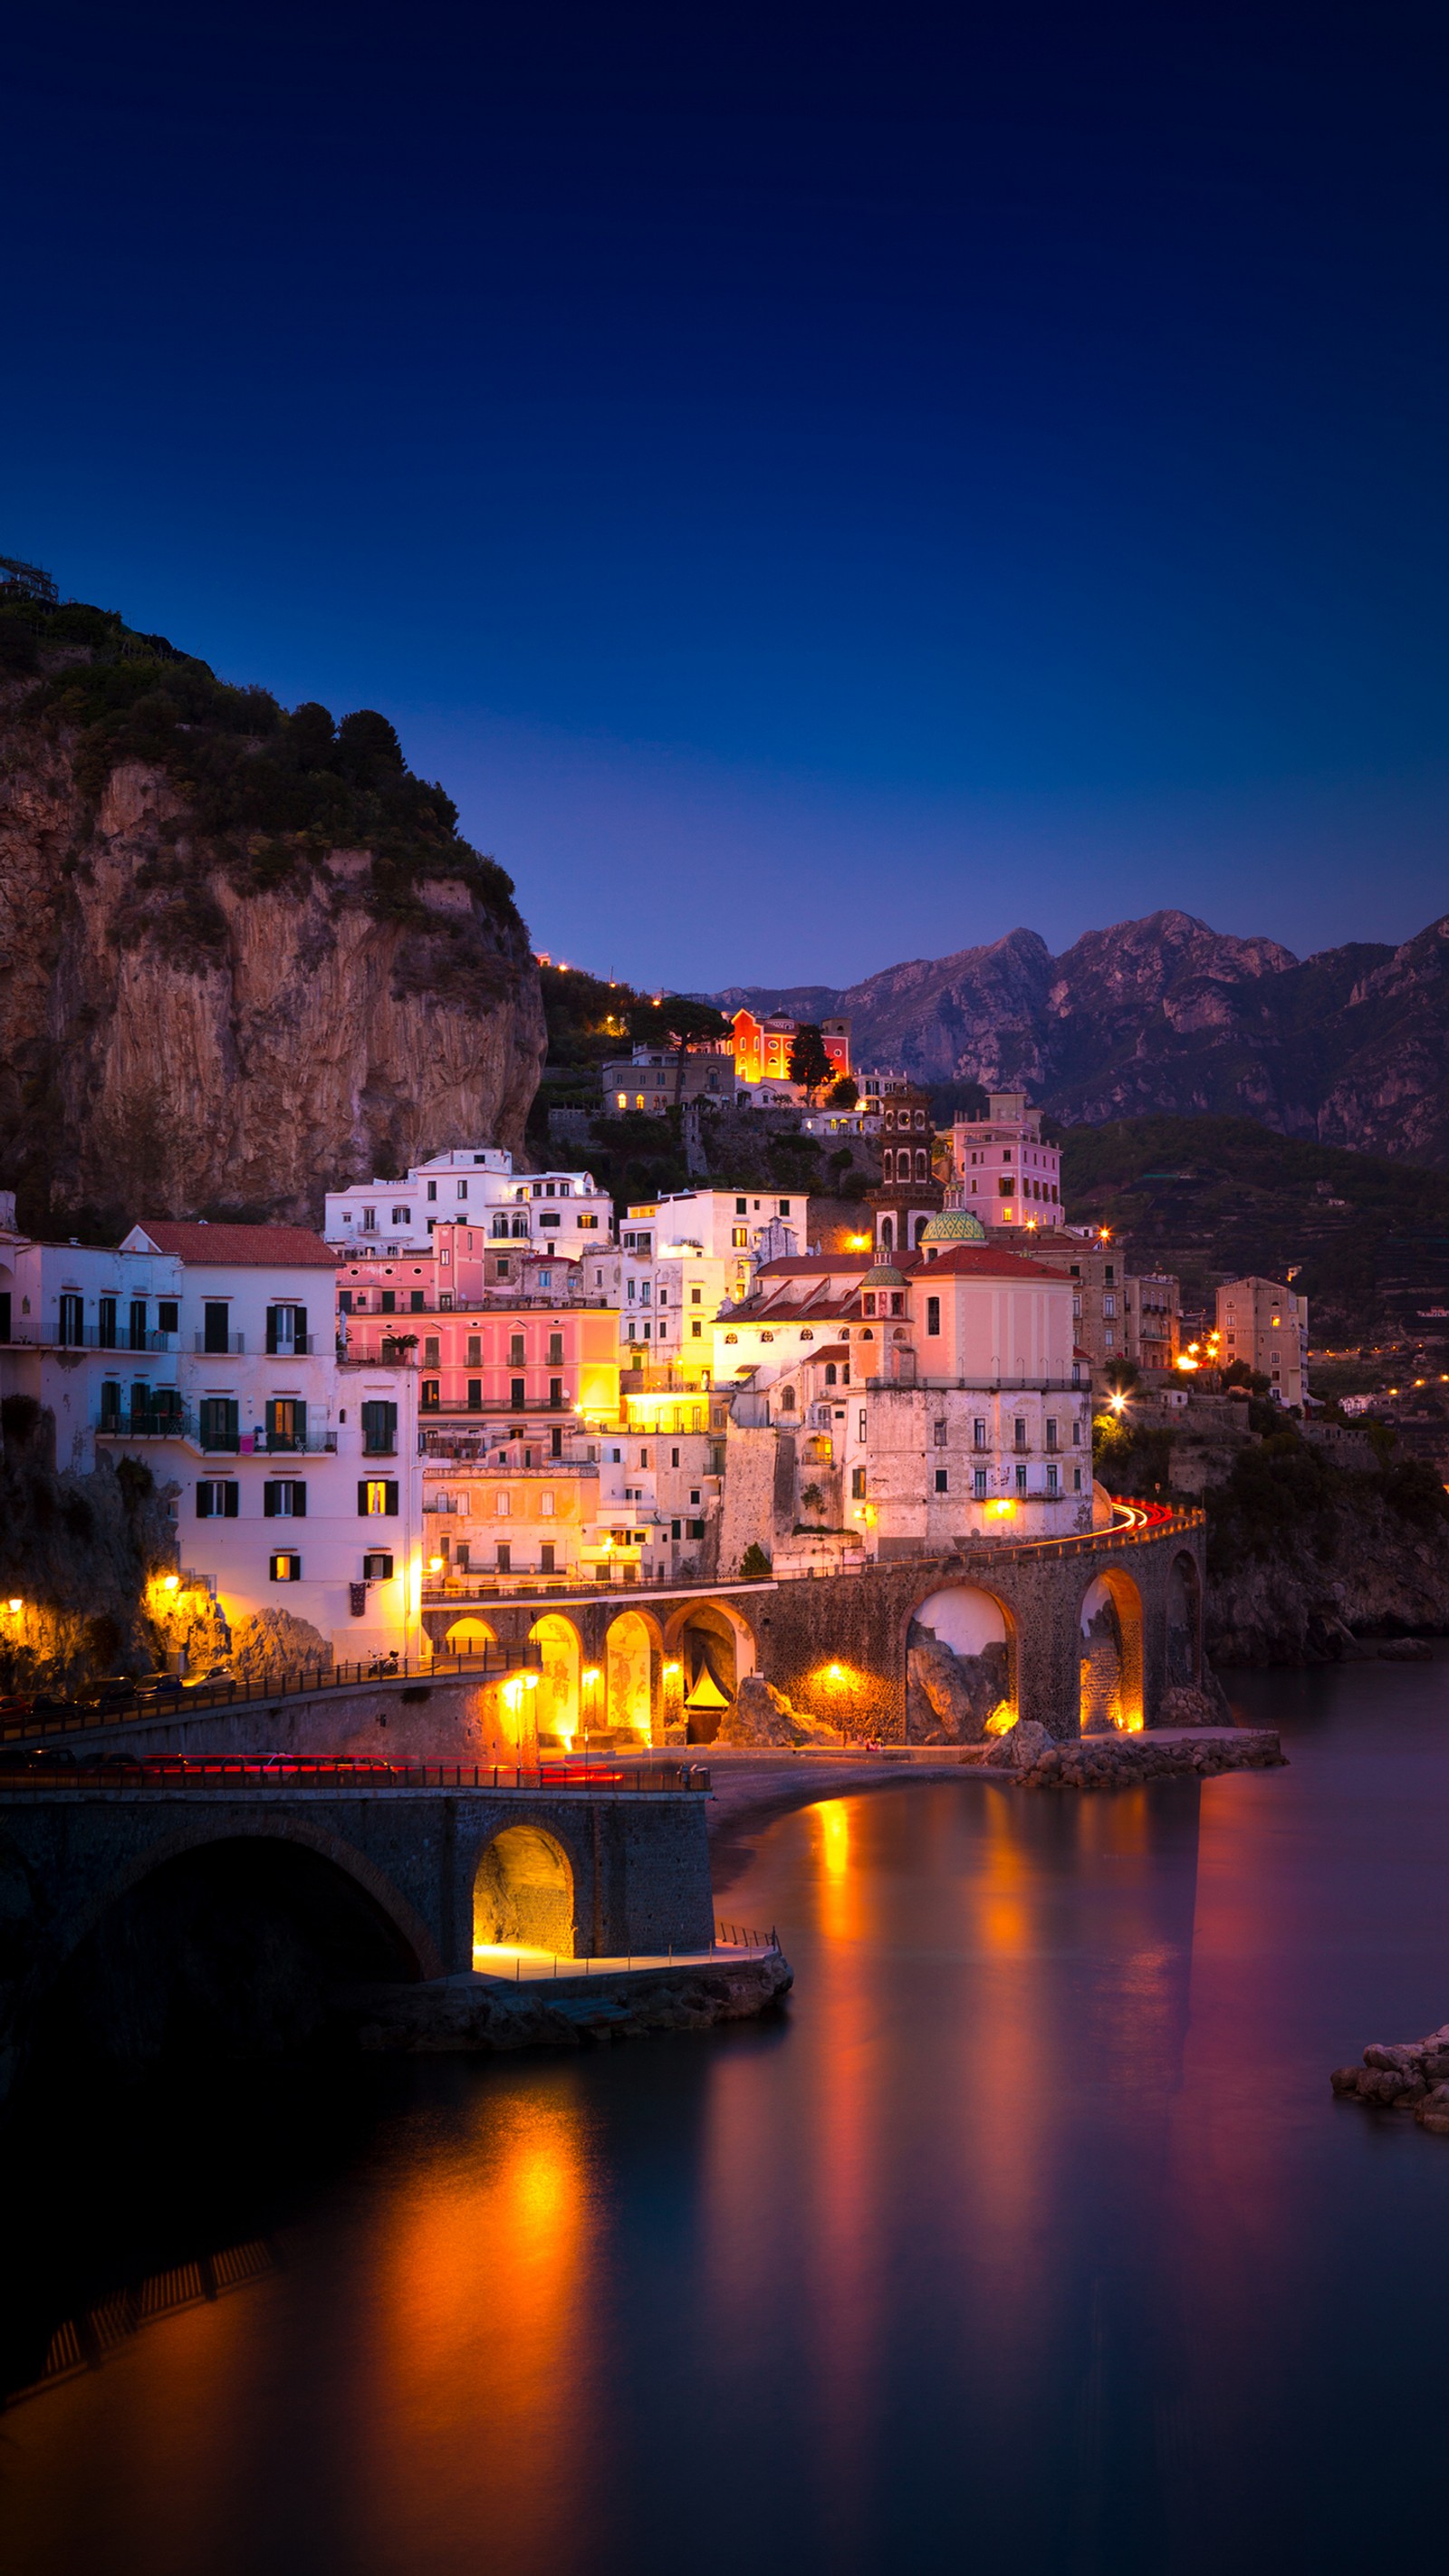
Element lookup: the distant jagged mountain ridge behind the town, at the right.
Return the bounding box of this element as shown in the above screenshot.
[710,912,1449,1167]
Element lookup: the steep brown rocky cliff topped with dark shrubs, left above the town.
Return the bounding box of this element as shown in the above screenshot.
[0,639,545,1229]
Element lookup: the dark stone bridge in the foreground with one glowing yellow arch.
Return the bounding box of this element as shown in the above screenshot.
[0,1770,713,2091]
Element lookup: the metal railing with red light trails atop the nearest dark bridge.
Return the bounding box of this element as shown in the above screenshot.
[0,1754,715,1793]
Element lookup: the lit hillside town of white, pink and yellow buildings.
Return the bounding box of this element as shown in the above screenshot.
[0,1056,1308,1742]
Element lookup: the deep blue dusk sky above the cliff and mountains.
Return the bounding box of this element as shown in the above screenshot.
[0,0,1449,984]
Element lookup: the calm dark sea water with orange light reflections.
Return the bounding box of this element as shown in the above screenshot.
[0,1664,1449,2576]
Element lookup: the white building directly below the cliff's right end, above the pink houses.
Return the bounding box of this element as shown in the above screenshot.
[321,1147,612,1260]
